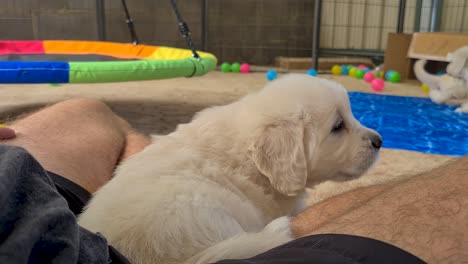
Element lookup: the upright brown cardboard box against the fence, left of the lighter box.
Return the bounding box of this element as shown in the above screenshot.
[384,33,414,81]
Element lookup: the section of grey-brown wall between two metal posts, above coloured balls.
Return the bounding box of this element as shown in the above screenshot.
[208,0,314,64]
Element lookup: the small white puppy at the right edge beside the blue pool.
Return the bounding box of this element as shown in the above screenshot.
[414,46,468,113]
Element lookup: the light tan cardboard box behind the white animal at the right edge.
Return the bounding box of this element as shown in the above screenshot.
[408,32,468,62]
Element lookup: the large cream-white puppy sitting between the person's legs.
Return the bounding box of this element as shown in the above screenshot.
[79,74,382,263]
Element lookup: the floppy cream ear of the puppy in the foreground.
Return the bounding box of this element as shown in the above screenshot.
[248,115,307,196]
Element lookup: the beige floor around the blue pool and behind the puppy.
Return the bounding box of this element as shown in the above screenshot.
[0,71,453,202]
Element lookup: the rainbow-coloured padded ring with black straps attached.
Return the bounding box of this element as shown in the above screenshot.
[0,40,217,83]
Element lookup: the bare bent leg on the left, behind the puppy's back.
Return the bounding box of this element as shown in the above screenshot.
[0,99,150,193]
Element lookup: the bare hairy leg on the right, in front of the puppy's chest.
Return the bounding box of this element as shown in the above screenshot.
[293,156,468,263]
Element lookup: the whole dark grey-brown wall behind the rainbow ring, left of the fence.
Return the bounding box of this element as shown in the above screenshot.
[0,0,313,65]
